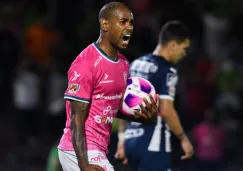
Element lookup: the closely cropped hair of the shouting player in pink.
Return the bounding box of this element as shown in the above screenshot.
[99,2,127,21]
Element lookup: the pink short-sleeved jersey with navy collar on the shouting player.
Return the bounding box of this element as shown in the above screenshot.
[58,43,129,153]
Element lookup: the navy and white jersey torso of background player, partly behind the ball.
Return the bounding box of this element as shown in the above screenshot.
[126,54,172,152]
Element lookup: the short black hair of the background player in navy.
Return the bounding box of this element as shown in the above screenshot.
[159,21,189,45]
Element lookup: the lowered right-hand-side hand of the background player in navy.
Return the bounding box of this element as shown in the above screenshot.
[181,136,194,160]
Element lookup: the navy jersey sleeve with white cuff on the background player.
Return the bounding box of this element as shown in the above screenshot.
[159,70,178,101]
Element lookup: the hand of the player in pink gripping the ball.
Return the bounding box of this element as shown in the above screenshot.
[134,94,159,123]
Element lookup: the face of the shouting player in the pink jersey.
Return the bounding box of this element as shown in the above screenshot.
[108,6,134,49]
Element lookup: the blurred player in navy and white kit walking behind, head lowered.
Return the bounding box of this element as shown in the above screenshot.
[115,21,193,171]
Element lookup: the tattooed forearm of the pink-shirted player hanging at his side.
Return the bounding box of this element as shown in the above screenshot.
[71,114,88,170]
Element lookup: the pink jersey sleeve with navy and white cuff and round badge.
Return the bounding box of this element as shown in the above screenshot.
[64,59,94,103]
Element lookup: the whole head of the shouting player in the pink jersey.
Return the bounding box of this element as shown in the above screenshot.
[99,2,134,49]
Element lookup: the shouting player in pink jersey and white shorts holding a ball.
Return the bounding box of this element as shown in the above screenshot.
[58,2,158,171]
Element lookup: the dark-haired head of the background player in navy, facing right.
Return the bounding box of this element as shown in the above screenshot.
[159,21,190,63]
